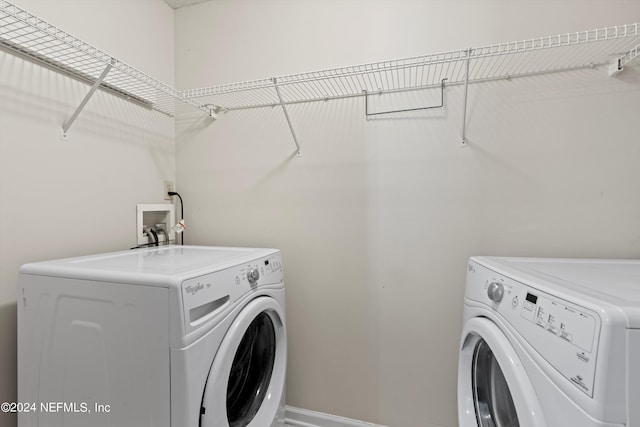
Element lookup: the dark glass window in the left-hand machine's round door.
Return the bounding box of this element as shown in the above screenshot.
[227,312,276,427]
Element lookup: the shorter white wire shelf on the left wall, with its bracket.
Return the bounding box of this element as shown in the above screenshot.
[0,0,210,136]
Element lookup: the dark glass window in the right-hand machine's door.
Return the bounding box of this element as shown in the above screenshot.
[472,340,520,427]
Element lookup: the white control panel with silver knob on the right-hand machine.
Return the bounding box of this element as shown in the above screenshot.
[466,262,601,397]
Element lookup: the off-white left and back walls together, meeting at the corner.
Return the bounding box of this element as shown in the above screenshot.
[0,0,640,427]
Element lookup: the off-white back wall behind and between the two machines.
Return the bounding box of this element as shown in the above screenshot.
[175,0,640,427]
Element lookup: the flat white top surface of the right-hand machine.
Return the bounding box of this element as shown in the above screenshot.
[473,257,640,328]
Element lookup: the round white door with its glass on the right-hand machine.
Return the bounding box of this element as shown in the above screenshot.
[458,317,546,427]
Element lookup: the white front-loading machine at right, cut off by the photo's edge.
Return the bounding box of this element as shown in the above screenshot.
[458,257,640,427]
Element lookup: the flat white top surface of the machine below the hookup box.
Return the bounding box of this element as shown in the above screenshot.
[20,246,277,286]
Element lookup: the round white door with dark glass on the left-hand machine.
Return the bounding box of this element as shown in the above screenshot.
[200,297,287,427]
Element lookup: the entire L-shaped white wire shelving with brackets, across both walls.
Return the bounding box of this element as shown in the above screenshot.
[0,0,640,150]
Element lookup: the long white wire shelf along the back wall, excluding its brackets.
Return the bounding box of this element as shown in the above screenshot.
[183,23,640,110]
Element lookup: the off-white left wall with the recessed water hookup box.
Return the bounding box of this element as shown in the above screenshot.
[0,0,175,426]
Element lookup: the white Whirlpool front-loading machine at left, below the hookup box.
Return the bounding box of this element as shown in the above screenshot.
[18,246,287,427]
